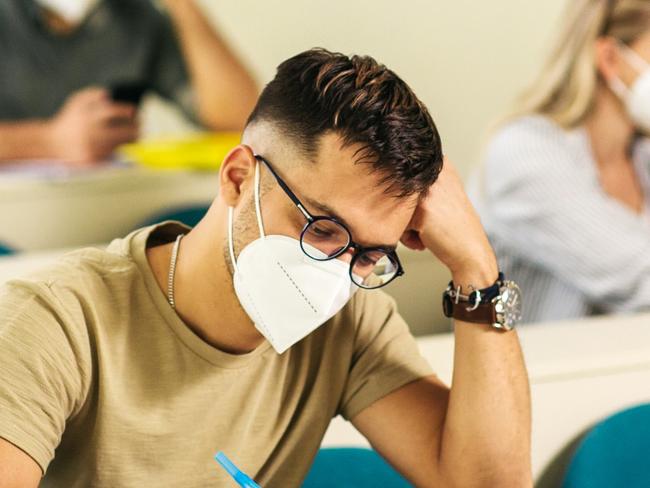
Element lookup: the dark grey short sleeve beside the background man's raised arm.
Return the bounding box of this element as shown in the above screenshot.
[149,7,199,123]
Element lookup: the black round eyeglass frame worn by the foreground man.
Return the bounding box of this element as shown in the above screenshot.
[254,154,404,290]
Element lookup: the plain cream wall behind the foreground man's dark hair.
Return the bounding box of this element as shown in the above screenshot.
[145,0,566,174]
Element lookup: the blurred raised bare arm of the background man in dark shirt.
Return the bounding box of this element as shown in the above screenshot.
[165,0,258,130]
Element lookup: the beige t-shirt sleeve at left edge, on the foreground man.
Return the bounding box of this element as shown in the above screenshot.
[0,282,84,472]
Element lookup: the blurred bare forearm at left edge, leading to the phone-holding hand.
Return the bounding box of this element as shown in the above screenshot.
[0,120,53,165]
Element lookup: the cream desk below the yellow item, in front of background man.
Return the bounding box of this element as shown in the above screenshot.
[0,165,218,251]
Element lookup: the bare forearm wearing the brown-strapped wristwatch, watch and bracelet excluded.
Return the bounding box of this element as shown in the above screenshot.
[439,263,532,488]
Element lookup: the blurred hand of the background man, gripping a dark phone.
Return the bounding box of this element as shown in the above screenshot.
[49,88,139,166]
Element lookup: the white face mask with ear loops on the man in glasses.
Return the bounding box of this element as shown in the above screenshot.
[228,163,358,354]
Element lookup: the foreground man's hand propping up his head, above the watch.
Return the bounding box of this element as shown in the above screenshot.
[402,160,498,288]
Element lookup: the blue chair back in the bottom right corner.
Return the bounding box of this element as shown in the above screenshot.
[563,404,650,488]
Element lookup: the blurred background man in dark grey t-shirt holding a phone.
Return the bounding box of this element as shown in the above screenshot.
[0,0,257,167]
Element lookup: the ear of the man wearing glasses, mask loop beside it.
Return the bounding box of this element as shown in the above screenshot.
[219,144,257,207]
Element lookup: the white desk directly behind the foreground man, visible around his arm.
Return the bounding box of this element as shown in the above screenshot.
[0,251,650,482]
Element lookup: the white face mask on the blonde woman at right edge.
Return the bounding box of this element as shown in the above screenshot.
[610,45,650,133]
